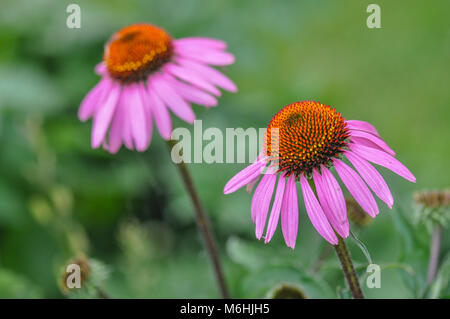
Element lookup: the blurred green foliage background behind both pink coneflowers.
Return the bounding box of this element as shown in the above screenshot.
[0,0,450,298]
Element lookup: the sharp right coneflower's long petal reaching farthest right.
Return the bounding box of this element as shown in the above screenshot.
[349,144,416,183]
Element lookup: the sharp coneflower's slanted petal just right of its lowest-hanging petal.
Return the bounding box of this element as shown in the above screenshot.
[300,175,338,245]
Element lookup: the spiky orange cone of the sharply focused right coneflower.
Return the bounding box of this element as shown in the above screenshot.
[265,101,349,177]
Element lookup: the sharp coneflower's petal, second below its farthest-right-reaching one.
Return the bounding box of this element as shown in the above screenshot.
[333,159,379,217]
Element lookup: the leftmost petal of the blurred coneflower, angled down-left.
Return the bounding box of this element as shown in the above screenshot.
[78,77,113,122]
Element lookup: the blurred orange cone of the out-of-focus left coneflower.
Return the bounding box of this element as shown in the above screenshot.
[103,24,173,81]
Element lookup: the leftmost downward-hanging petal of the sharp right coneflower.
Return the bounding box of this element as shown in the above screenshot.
[251,174,277,239]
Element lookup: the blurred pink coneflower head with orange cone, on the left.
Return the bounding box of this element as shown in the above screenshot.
[78,24,237,153]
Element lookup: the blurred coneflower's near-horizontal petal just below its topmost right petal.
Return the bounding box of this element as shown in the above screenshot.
[174,46,234,66]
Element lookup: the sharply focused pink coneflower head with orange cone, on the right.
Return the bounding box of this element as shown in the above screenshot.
[224,101,416,249]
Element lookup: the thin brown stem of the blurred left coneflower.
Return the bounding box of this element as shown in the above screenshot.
[167,140,230,299]
